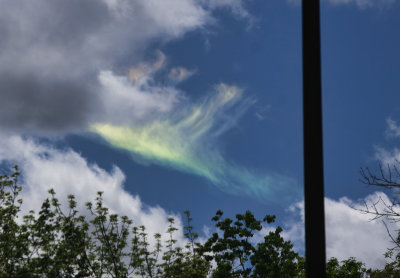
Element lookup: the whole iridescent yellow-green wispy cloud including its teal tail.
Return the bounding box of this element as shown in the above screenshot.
[91,84,299,203]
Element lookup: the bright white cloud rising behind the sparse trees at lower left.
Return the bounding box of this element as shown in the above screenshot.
[0,136,185,248]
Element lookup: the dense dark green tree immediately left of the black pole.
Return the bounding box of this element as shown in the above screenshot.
[201,211,303,278]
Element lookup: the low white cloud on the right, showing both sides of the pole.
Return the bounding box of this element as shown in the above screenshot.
[272,192,400,268]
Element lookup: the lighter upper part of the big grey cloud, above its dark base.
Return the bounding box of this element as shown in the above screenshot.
[0,0,211,78]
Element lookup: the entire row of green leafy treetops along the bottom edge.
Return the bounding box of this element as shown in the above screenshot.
[0,166,400,278]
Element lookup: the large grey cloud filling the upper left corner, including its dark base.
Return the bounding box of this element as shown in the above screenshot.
[0,0,250,133]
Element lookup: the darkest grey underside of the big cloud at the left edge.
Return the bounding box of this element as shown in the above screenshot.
[0,74,98,134]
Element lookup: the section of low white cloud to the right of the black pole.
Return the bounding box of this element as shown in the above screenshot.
[325,192,400,267]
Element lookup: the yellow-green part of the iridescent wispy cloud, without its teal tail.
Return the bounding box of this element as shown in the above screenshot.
[91,84,242,182]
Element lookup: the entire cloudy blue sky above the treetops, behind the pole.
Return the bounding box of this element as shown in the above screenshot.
[0,0,400,267]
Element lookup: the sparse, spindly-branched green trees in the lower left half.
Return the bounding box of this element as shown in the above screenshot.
[0,167,209,278]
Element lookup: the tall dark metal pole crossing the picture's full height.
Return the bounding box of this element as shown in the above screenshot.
[302,0,326,278]
